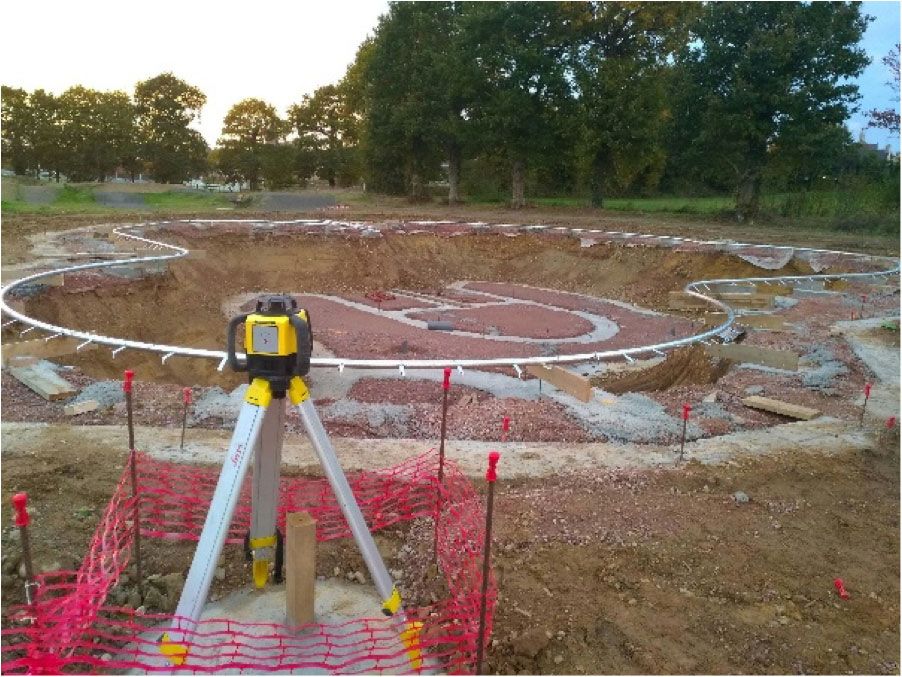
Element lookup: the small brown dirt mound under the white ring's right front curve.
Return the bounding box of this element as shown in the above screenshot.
[592,346,730,395]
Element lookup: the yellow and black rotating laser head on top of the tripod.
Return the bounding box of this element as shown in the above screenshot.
[228,295,313,397]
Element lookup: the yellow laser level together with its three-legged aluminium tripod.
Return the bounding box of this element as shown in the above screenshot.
[160,295,401,665]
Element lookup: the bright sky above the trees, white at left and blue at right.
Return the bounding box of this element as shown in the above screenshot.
[0,0,900,151]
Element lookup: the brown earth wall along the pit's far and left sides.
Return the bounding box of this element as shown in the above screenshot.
[19,229,809,385]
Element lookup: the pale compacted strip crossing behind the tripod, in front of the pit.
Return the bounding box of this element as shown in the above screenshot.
[0,418,882,478]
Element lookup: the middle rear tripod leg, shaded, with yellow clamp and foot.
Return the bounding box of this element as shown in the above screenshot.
[248,399,285,588]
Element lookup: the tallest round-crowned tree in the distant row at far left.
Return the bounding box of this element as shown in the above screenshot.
[135,73,209,183]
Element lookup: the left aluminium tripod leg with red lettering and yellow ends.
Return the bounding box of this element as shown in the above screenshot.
[160,378,272,665]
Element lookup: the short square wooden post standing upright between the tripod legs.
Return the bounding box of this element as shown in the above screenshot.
[285,512,316,625]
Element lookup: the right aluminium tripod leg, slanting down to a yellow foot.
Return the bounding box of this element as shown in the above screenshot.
[288,376,401,616]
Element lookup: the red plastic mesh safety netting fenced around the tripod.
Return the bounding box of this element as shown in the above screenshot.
[2,453,496,674]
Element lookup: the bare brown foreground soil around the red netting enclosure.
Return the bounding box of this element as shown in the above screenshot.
[2,422,899,674]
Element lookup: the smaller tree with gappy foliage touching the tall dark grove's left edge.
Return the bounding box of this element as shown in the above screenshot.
[288,84,358,188]
